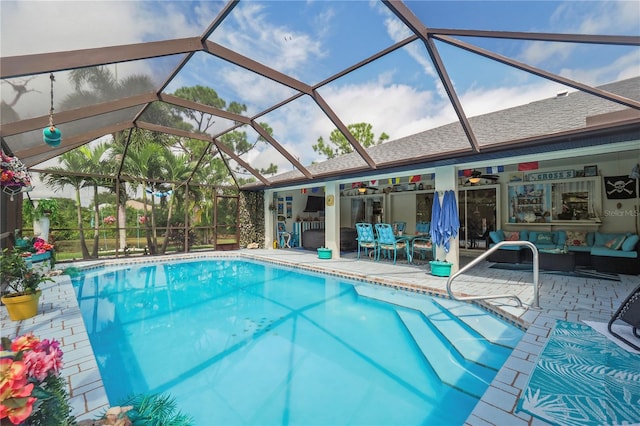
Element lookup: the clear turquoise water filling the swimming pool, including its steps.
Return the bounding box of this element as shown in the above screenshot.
[73,259,522,425]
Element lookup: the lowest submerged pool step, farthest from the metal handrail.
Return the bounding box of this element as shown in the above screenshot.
[397,310,496,398]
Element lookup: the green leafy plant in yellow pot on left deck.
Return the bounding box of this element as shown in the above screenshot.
[0,249,53,321]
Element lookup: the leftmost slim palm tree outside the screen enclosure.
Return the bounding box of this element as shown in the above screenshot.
[42,150,90,259]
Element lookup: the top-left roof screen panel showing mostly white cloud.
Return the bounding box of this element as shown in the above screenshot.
[0,0,220,56]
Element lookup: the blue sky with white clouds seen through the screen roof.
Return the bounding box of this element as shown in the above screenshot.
[0,0,640,200]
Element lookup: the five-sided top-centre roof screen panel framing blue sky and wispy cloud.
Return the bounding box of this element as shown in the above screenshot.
[210,1,399,85]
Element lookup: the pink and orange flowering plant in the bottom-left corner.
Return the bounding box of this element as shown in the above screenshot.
[0,333,75,425]
